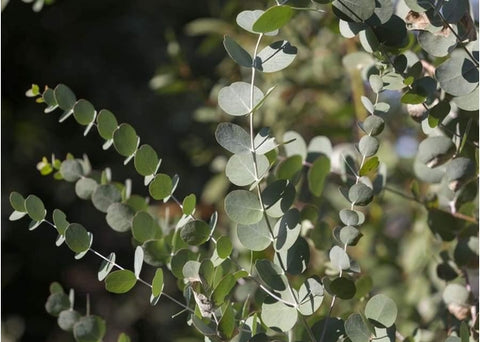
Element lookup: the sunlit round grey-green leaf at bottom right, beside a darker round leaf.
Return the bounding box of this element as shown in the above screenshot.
[365,294,398,328]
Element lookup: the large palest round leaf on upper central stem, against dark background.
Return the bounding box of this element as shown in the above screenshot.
[218,82,264,116]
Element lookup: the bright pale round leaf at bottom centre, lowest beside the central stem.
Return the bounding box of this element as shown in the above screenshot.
[261,302,298,331]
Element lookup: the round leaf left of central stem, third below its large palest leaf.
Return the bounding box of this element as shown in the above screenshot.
[225,190,263,225]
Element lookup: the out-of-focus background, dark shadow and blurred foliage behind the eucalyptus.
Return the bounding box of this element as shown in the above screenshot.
[2,0,478,342]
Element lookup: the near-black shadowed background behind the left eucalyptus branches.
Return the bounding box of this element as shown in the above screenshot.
[1,0,234,341]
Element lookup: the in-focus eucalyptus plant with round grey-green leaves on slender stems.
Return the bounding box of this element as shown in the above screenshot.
[10,0,479,342]
